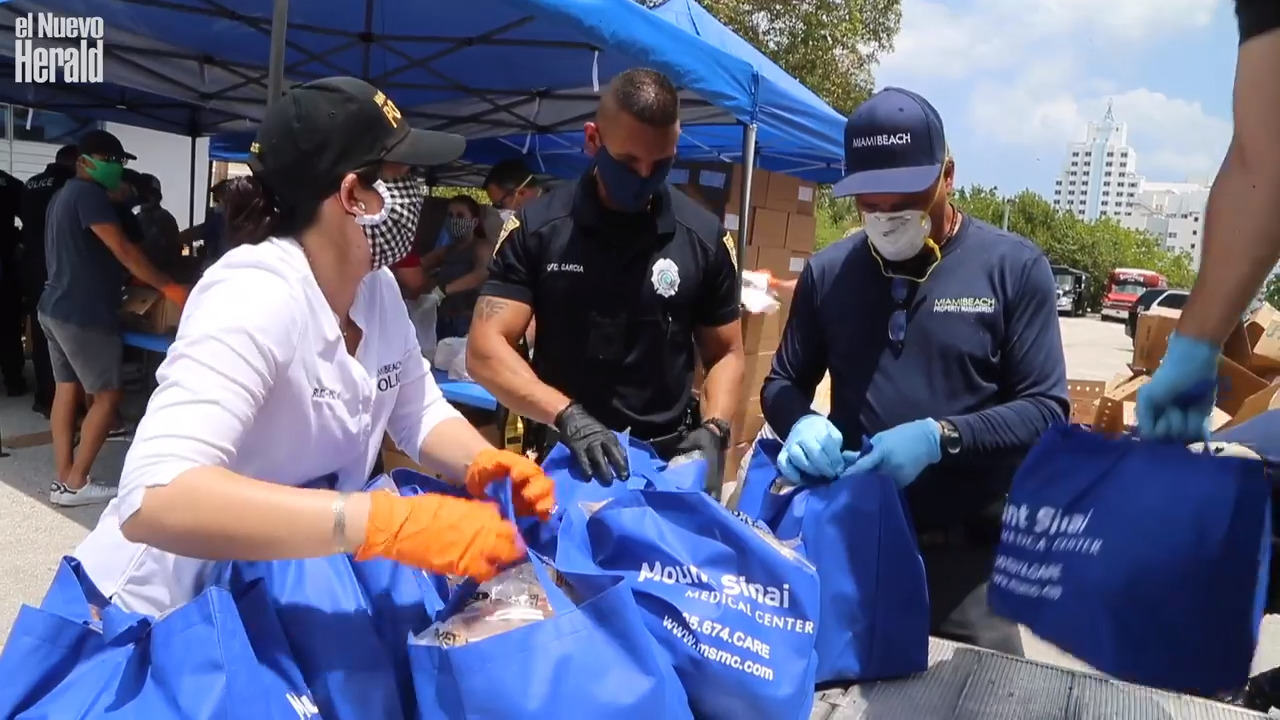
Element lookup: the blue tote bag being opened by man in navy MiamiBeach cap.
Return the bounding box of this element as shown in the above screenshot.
[737,439,929,683]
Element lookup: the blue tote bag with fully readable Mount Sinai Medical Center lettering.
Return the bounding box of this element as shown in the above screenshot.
[556,482,818,720]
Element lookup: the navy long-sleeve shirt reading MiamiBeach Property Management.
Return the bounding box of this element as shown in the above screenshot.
[760,217,1069,529]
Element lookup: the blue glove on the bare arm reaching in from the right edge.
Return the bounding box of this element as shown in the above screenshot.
[1138,333,1221,443]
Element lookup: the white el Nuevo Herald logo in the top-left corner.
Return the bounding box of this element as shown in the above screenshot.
[13,12,106,83]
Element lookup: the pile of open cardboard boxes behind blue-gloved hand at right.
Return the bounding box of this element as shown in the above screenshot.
[1069,305,1280,433]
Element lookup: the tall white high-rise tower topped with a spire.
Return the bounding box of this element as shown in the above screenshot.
[1053,102,1143,220]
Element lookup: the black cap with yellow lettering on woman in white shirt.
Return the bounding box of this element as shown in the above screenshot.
[248,77,466,205]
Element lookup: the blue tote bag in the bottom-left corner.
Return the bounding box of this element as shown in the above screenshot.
[0,557,321,720]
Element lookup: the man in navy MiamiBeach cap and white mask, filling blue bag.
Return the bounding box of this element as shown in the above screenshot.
[760,87,1068,655]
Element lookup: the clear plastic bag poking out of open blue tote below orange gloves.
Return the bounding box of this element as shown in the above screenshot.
[412,564,554,647]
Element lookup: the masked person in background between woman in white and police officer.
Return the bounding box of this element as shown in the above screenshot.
[422,195,494,340]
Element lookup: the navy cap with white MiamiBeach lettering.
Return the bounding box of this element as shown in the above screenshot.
[832,87,947,197]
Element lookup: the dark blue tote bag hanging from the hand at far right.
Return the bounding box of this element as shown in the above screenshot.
[988,425,1271,696]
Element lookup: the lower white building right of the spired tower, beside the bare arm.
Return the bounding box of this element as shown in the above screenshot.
[1120,182,1210,270]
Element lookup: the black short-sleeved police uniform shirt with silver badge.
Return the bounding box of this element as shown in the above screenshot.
[480,173,739,439]
